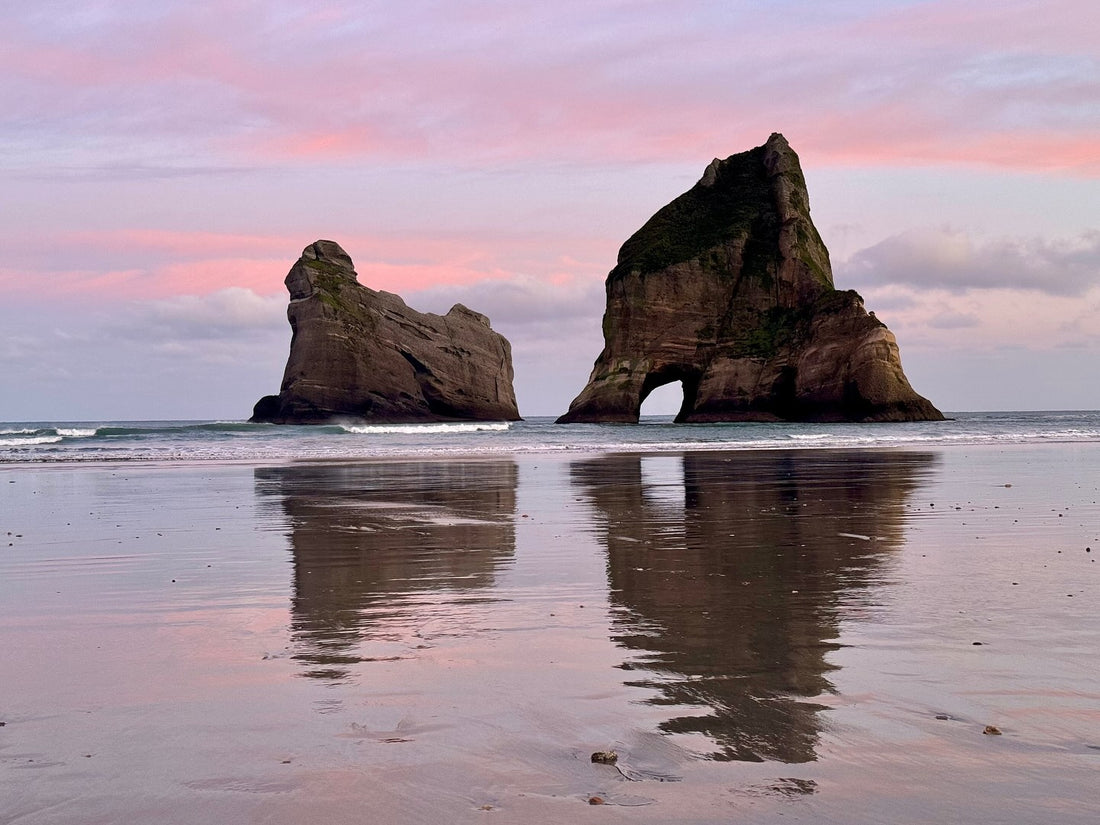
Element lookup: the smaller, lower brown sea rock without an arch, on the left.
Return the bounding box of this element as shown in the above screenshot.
[250,241,519,424]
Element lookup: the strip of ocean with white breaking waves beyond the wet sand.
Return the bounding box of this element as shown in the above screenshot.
[0,410,1100,463]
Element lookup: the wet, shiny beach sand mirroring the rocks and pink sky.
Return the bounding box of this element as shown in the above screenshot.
[0,444,1100,823]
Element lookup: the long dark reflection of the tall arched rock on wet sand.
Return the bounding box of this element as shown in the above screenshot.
[571,451,934,762]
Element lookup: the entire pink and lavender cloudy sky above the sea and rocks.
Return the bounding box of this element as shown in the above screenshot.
[0,0,1100,421]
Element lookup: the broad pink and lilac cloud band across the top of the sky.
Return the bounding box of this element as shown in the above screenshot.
[0,0,1100,175]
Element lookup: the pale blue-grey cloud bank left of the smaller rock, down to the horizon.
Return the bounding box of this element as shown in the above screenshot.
[0,296,290,420]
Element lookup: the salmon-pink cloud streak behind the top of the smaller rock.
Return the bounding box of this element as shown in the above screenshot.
[0,229,611,303]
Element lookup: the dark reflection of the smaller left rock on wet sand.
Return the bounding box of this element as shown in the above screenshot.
[255,460,517,681]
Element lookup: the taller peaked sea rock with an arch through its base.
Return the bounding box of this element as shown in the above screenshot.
[558,134,943,422]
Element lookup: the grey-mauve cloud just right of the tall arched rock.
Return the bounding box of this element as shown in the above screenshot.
[838,229,1100,296]
